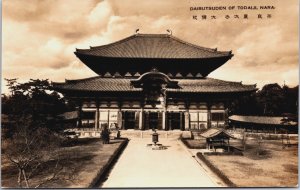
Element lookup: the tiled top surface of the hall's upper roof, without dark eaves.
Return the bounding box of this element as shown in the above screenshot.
[75,34,232,59]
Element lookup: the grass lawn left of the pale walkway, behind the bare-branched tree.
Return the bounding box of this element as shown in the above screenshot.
[1,139,124,188]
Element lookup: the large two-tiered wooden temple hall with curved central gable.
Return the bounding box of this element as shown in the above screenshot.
[53,34,257,131]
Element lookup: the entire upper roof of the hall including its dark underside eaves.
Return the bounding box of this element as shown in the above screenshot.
[74,34,233,77]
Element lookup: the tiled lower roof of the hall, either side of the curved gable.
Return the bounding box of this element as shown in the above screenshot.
[52,76,257,93]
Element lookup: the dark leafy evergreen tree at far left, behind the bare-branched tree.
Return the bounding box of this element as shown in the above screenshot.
[2,79,66,133]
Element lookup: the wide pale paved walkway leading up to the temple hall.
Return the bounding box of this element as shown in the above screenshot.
[102,138,218,188]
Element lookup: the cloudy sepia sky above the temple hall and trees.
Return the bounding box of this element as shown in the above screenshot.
[1,0,299,93]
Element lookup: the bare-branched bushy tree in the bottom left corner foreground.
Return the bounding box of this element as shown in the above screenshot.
[4,118,74,188]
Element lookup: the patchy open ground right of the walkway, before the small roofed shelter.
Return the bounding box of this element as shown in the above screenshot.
[206,140,298,187]
